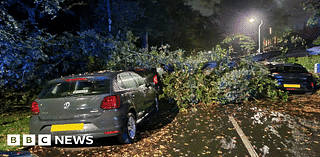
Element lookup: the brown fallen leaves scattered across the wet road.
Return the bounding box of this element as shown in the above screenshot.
[29,94,320,157]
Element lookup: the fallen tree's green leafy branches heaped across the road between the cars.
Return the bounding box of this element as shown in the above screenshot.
[163,50,288,108]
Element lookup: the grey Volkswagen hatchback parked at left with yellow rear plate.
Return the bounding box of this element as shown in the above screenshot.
[30,71,158,143]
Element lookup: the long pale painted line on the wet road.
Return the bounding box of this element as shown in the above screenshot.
[229,116,259,157]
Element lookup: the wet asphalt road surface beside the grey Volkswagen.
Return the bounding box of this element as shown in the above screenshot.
[27,96,320,157]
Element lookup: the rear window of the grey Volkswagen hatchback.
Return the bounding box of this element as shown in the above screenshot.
[38,79,110,98]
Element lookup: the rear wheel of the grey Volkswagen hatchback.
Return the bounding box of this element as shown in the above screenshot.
[118,113,137,143]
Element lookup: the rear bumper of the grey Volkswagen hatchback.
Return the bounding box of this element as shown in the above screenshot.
[29,111,125,139]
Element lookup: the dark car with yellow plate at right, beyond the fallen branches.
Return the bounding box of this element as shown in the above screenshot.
[268,63,316,94]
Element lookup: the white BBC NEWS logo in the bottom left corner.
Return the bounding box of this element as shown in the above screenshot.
[7,134,93,146]
